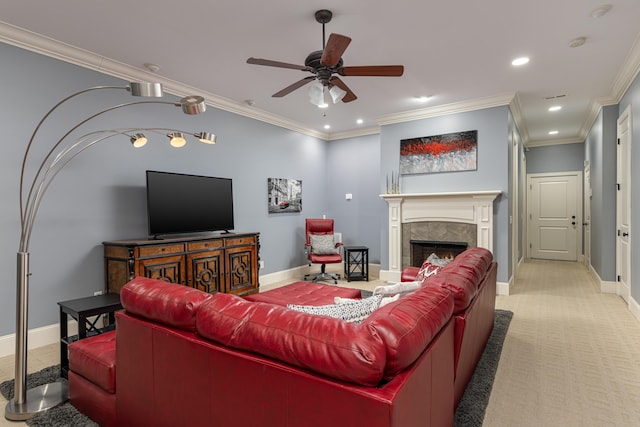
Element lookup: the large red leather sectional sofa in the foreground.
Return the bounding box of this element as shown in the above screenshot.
[69,248,496,427]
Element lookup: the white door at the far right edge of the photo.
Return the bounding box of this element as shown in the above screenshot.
[616,106,632,302]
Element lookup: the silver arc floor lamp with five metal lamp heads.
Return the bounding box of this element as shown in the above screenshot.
[5,82,215,421]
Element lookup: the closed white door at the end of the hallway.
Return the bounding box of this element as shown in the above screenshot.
[528,172,582,261]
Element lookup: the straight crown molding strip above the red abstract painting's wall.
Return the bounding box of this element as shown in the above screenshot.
[376,93,514,126]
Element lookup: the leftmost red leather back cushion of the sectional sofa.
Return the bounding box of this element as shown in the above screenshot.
[120,277,211,331]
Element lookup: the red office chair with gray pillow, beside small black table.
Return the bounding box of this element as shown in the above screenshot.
[304,218,342,284]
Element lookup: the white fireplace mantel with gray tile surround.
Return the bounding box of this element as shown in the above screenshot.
[380,191,501,282]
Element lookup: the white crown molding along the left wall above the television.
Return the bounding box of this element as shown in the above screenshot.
[0,22,329,140]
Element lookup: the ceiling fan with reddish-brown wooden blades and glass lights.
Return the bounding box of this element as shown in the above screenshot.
[247,9,404,105]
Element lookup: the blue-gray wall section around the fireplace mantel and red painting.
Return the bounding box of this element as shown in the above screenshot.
[379,106,510,282]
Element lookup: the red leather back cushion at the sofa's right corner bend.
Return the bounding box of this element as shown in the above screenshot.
[362,287,453,378]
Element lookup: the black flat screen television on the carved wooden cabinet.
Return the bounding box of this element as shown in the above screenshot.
[147,170,234,238]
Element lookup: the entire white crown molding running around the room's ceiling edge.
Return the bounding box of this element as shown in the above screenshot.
[0,22,640,147]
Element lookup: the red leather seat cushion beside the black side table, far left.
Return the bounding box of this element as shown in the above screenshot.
[69,331,116,393]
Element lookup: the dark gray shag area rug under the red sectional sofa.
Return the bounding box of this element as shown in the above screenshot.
[0,310,513,427]
